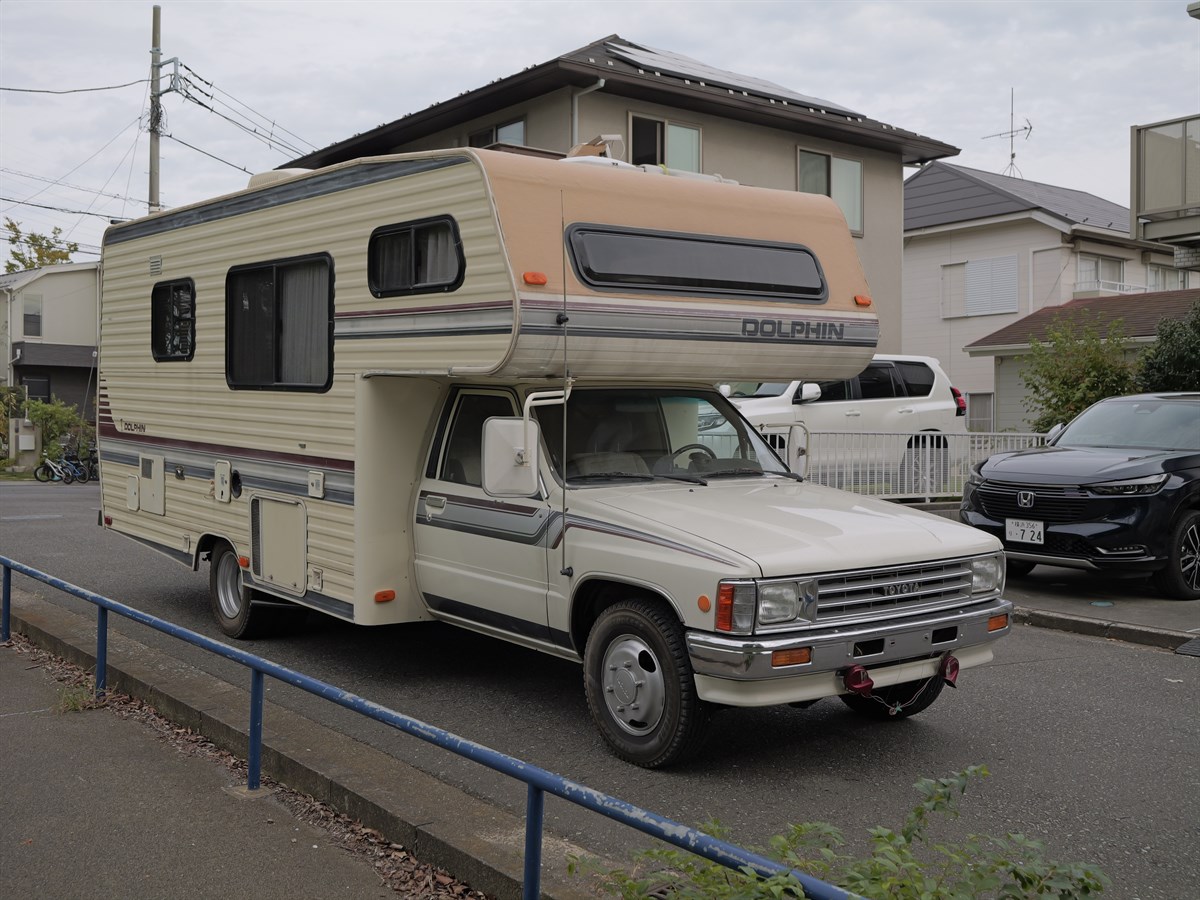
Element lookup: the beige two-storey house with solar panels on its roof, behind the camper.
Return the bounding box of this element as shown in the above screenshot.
[281,35,959,352]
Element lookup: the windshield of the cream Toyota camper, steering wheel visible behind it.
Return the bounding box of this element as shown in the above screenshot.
[535,388,790,484]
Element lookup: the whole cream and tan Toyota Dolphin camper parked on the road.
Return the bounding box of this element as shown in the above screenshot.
[98,150,1010,767]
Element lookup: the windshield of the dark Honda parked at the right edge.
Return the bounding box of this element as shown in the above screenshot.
[1054,397,1200,450]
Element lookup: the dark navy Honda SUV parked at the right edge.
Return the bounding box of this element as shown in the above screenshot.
[960,392,1200,600]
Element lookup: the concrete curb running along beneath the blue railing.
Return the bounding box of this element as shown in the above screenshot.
[11,590,604,900]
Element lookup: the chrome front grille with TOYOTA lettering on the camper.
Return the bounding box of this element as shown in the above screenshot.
[817,559,971,624]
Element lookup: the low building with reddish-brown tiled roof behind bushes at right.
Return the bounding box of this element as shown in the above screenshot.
[964,288,1200,431]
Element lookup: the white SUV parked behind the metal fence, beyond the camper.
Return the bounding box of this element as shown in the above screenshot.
[722,354,967,493]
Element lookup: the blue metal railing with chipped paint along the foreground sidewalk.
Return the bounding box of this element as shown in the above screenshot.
[0,556,857,900]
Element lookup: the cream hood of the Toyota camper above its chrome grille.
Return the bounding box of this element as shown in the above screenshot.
[571,478,1001,577]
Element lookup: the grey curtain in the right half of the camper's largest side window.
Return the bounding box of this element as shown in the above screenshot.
[280,262,329,385]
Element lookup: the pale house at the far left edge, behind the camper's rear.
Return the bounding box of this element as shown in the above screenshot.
[0,263,100,419]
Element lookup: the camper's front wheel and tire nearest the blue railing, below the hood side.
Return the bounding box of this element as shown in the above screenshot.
[583,600,712,769]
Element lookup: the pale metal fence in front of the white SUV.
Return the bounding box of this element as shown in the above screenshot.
[762,427,1045,500]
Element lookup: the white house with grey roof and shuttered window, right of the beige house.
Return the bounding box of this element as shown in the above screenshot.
[902,162,1200,431]
